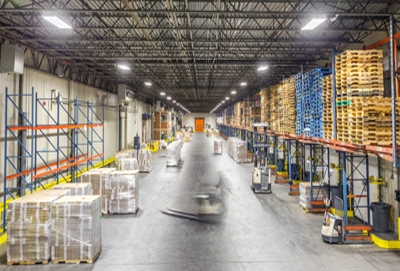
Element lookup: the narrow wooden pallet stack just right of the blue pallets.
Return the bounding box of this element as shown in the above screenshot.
[322,75,333,139]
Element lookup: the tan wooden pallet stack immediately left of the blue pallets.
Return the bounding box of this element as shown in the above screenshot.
[283,76,296,134]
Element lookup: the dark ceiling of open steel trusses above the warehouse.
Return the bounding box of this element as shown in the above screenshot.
[0,0,400,112]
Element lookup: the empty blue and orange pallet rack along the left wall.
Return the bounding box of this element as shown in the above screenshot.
[2,88,104,232]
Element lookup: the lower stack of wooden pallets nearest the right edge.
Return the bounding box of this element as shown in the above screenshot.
[348,96,400,146]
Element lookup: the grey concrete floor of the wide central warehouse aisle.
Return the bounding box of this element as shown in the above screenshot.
[0,134,400,271]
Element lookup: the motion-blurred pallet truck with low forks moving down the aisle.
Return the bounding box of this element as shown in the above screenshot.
[161,181,224,223]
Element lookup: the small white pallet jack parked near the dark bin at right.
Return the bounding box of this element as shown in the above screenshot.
[321,198,344,244]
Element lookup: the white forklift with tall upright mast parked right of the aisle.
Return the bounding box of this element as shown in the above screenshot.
[250,123,272,194]
